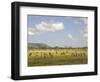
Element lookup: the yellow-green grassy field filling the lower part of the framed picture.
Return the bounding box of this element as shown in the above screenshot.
[28,48,88,67]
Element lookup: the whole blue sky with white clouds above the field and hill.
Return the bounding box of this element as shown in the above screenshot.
[27,15,88,47]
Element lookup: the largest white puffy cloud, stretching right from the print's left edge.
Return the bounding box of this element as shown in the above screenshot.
[28,21,64,35]
